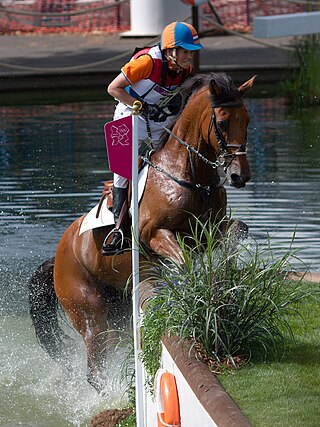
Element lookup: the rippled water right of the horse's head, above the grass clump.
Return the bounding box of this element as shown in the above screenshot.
[228,99,320,271]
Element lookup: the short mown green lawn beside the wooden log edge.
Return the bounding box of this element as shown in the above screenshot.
[219,282,320,427]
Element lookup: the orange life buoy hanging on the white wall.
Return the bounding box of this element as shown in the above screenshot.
[156,369,181,427]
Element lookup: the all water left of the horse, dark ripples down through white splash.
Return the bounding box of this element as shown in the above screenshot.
[0,103,130,427]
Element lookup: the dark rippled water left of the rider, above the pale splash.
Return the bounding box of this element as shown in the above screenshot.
[0,102,113,312]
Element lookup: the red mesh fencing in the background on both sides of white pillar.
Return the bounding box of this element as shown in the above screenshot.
[0,0,318,34]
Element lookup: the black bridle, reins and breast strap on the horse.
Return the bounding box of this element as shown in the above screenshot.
[142,97,247,197]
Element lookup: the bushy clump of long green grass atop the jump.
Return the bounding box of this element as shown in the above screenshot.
[142,222,312,379]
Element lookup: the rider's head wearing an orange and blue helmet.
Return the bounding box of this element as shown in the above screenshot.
[160,21,203,69]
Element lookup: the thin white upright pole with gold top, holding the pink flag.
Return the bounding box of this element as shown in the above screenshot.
[132,101,146,427]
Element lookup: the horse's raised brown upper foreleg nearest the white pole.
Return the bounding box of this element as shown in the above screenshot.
[150,228,183,264]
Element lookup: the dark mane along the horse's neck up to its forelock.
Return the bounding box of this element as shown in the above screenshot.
[157,73,239,150]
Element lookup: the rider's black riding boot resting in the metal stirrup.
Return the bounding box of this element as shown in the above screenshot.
[102,187,128,255]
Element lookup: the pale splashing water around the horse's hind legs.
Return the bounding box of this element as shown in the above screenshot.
[0,316,131,427]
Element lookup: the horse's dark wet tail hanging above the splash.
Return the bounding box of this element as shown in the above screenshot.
[28,258,70,360]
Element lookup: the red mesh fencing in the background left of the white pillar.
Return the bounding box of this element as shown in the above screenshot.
[0,0,130,33]
